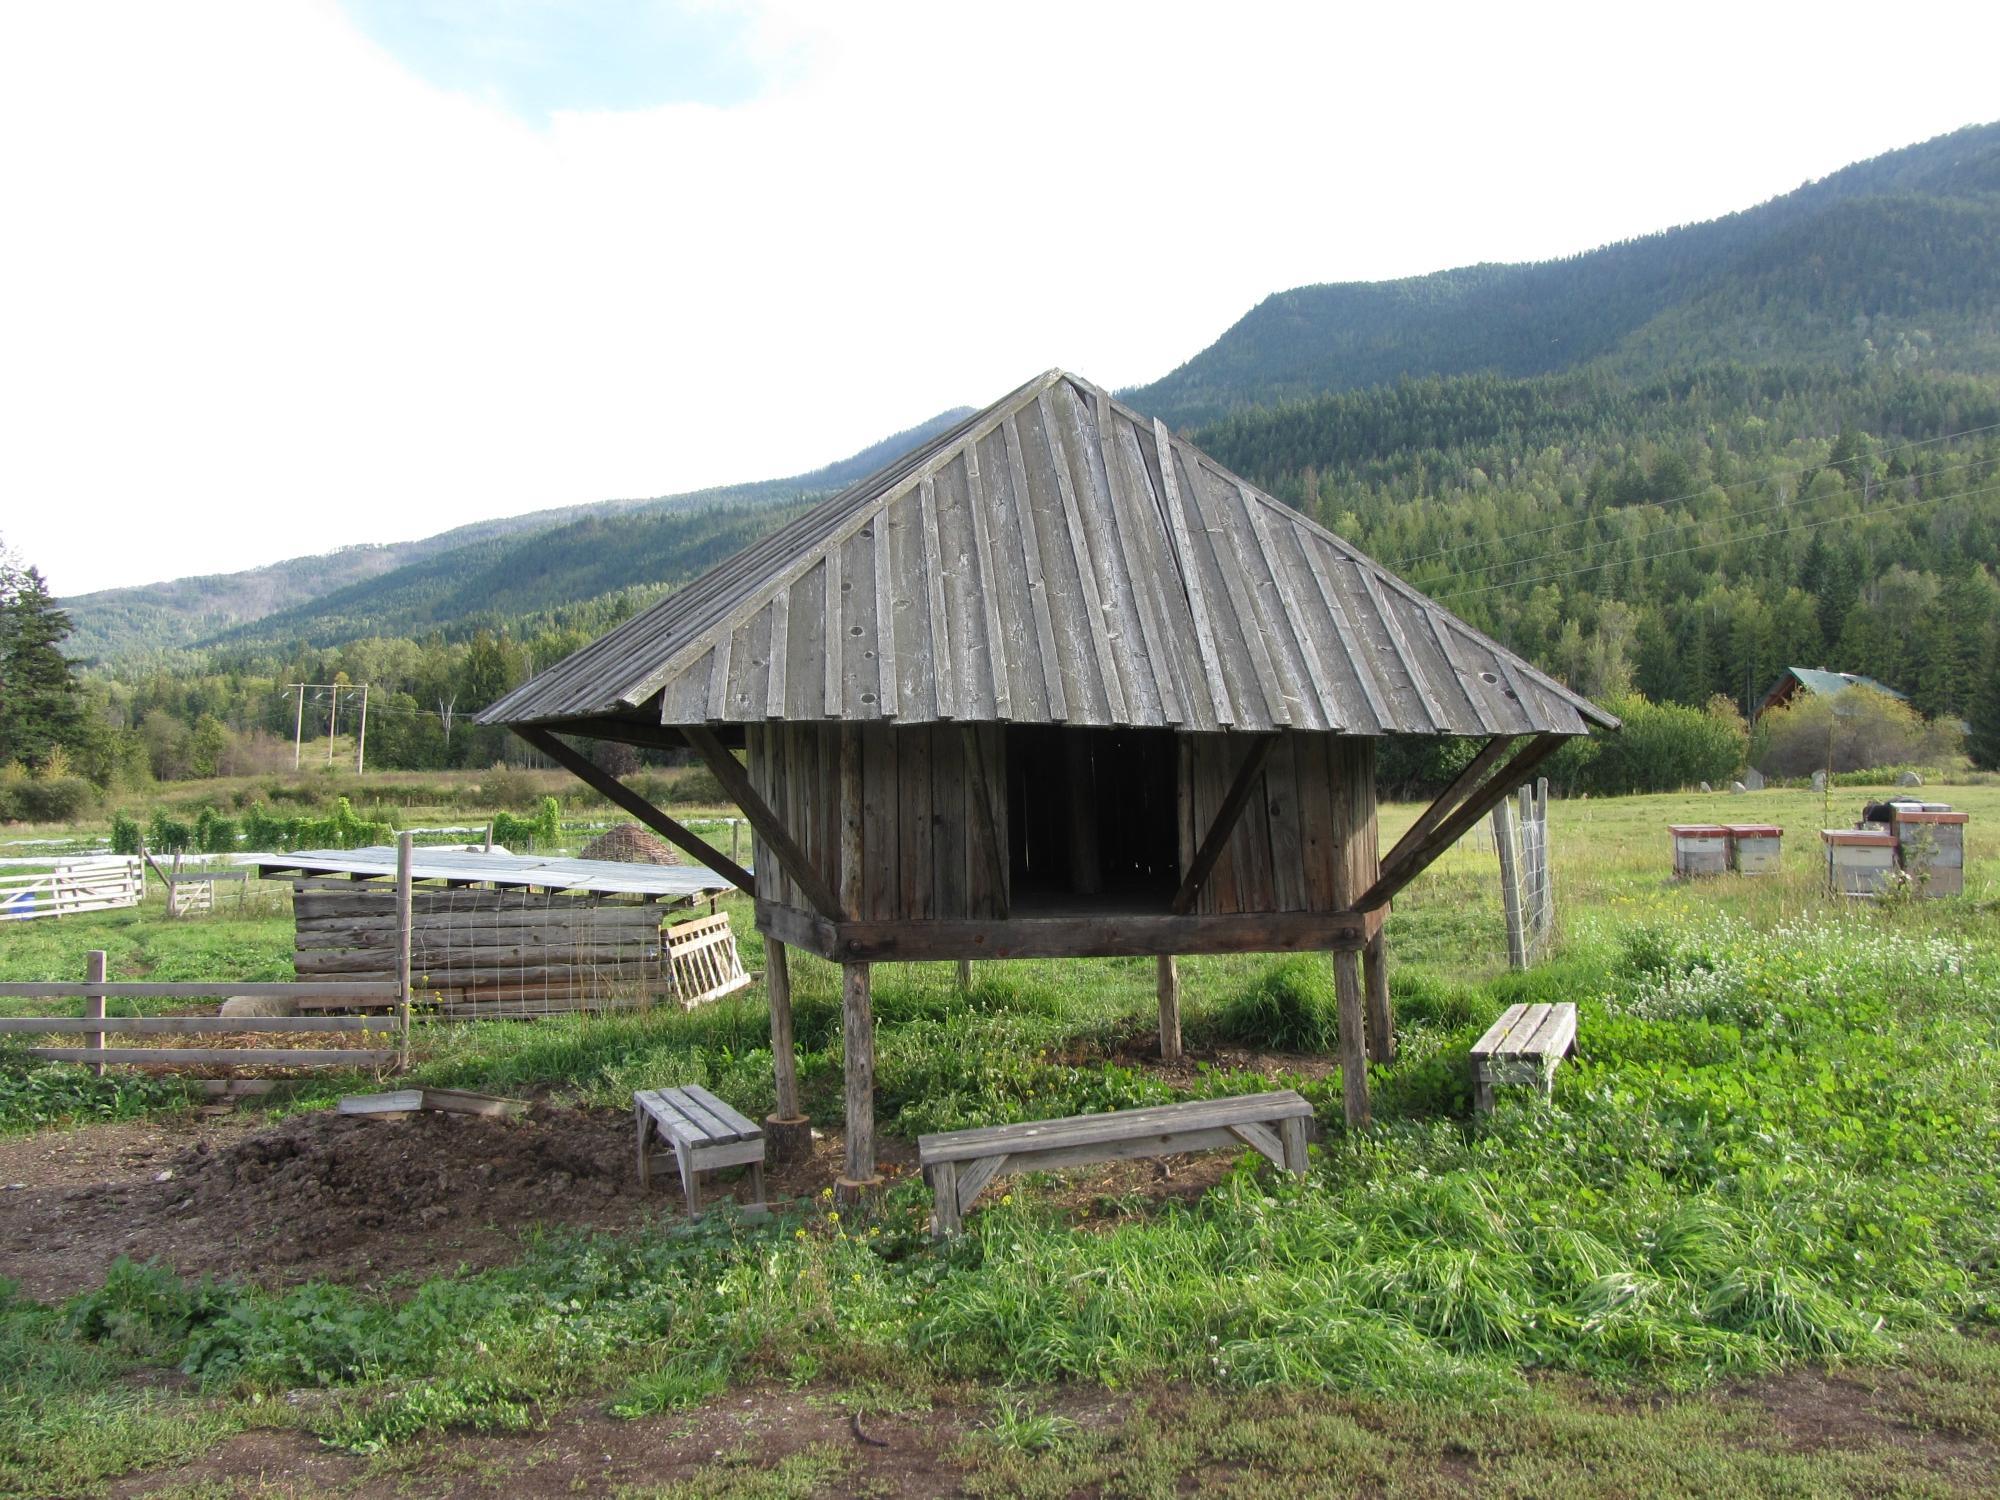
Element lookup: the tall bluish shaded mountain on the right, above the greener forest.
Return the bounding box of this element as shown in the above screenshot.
[1126,124,2000,426]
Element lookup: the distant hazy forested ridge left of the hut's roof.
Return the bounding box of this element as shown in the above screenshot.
[62,408,968,662]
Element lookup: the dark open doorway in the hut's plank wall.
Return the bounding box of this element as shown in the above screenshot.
[1006,724,1180,912]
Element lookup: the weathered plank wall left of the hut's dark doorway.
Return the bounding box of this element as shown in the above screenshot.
[744,722,1008,922]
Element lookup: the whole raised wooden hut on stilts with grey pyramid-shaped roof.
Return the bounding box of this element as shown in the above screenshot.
[480,370,1616,1188]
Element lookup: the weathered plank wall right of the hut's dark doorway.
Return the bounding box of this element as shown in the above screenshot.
[1180,732,1380,916]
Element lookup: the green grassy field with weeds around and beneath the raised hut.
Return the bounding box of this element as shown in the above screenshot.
[0,788,2000,1496]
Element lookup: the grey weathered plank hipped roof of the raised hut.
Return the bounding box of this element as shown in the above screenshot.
[480,370,1618,734]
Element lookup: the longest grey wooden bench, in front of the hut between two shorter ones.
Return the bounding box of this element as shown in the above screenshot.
[916,1088,1312,1236]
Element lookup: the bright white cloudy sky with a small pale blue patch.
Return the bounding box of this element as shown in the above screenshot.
[0,0,2000,594]
